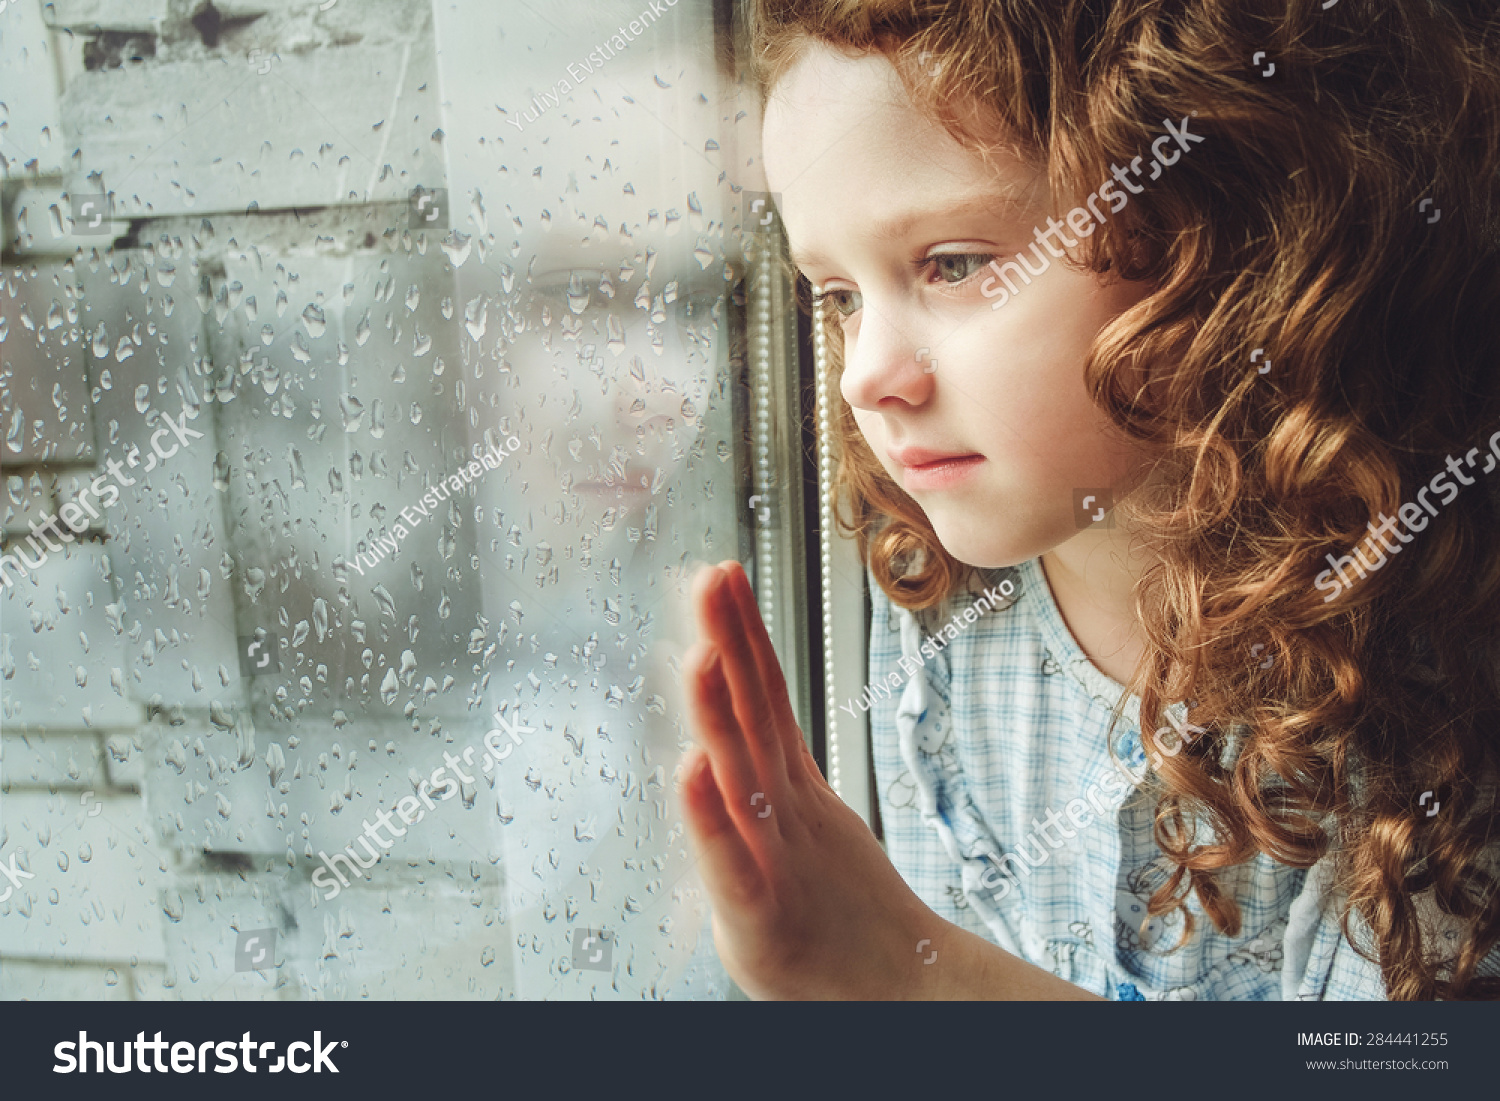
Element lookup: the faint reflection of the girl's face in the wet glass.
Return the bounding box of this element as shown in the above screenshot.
[459,40,731,594]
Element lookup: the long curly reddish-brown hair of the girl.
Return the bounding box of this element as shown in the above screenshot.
[750,0,1500,999]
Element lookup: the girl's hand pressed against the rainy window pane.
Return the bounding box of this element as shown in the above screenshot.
[681,563,948,999]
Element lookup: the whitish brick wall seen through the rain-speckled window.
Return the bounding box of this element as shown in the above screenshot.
[0,0,743,999]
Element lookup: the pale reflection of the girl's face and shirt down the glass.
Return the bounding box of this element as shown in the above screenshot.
[435,17,734,998]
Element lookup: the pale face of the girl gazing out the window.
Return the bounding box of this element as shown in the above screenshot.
[764,45,1146,567]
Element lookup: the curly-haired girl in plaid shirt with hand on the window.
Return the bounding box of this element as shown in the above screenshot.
[683,0,1500,1001]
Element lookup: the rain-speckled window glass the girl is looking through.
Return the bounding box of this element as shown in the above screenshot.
[0,0,795,999]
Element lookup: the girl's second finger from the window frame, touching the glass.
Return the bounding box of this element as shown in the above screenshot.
[695,567,786,792]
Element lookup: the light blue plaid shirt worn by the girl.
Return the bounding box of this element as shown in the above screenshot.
[860,560,1500,1001]
